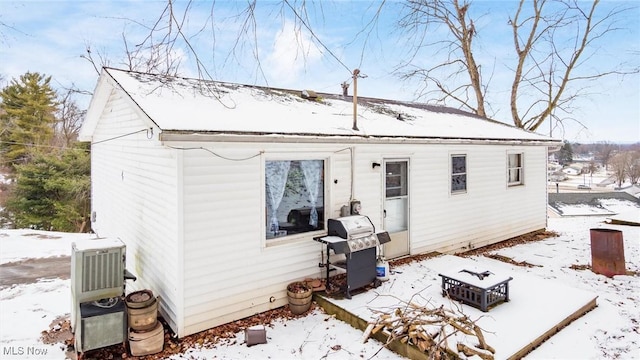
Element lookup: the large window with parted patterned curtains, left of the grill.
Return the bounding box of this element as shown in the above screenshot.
[265,160,324,239]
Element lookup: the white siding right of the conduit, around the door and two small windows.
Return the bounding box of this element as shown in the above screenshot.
[354,145,546,254]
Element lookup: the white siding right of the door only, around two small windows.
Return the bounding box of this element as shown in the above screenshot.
[410,145,546,254]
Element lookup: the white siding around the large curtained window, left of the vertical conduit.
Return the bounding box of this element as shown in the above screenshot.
[182,144,350,335]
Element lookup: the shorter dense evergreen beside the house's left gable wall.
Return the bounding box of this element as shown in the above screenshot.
[5,146,91,232]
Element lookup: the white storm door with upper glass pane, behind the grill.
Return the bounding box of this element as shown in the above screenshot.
[383,160,409,259]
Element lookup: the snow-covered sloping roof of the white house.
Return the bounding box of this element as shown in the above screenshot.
[81,68,560,145]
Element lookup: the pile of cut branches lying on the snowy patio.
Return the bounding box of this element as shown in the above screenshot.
[362,301,495,360]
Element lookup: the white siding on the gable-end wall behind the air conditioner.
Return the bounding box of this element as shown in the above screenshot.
[91,93,182,334]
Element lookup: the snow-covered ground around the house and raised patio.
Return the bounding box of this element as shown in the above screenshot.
[0,200,640,360]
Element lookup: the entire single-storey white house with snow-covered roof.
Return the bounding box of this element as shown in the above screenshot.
[81,68,561,337]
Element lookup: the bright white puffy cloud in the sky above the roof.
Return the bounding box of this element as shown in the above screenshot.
[263,20,322,84]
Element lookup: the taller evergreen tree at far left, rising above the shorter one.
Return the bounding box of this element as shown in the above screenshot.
[0,72,58,165]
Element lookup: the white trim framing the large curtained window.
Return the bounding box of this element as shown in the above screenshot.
[260,153,330,248]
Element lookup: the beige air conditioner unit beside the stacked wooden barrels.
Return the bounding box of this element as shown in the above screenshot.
[71,239,127,353]
